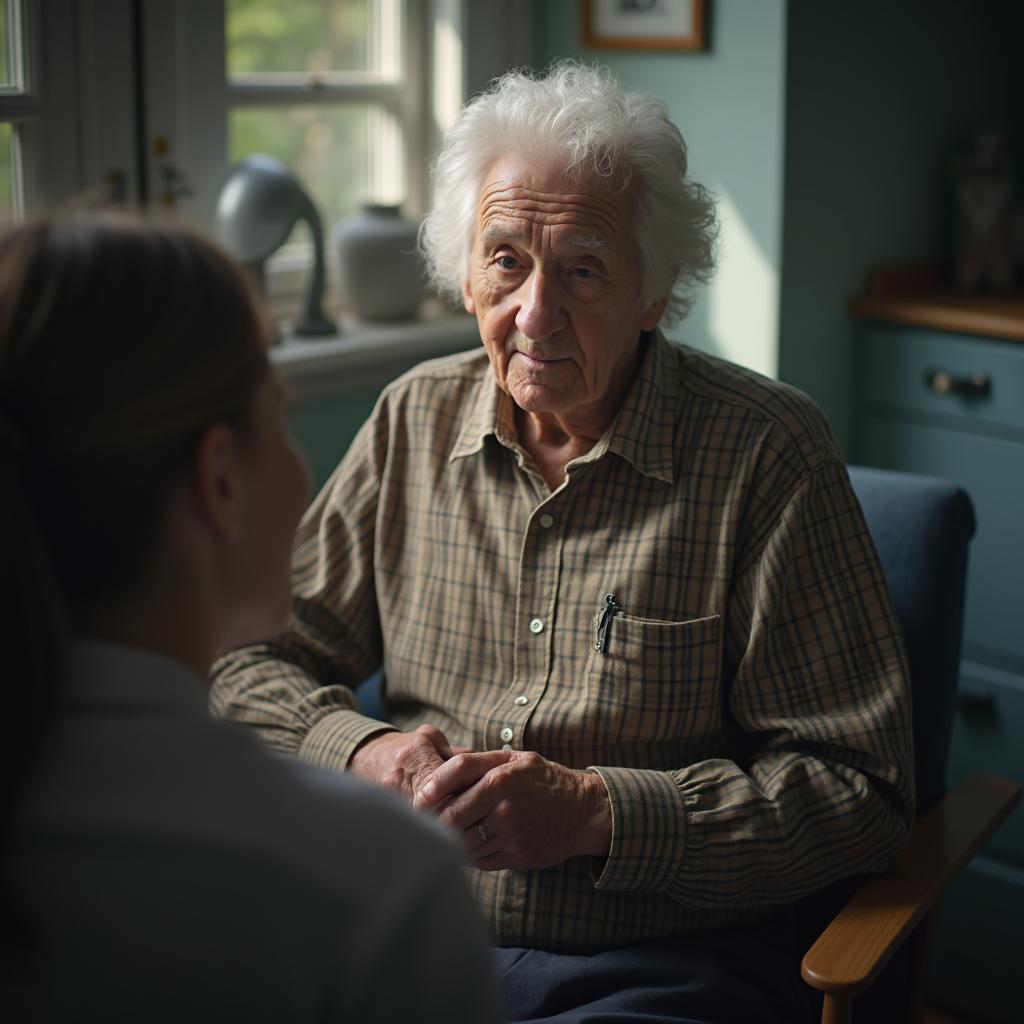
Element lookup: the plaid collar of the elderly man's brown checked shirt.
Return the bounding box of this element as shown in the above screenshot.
[449,331,676,483]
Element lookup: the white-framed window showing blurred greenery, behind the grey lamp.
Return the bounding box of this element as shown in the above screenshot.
[216,0,427,313]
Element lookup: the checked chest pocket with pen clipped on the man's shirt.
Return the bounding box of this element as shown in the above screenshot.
[585,612,722,743]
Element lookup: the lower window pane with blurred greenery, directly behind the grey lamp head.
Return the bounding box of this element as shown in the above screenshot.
[228,104,404,233]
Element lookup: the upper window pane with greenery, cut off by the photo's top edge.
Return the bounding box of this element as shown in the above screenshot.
[226,0,378,75]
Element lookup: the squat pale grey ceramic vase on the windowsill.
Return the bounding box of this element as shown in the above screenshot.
[334,203,427,321]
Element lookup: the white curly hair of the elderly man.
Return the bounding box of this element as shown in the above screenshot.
[420,60,718,325]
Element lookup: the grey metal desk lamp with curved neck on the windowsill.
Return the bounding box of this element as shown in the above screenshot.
[215,154,338,337]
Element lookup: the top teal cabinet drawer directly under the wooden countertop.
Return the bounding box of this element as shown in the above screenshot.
[863,325,1024,430]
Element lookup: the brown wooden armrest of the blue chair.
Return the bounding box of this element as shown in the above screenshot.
[801,775,1021,996]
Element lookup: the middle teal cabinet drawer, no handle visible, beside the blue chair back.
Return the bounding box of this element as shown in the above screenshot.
[860,415,1024,667]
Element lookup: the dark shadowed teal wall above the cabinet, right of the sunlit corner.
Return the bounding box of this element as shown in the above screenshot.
[778,0,1024,449]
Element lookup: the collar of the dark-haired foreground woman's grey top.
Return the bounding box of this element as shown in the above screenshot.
[67,641,209,718]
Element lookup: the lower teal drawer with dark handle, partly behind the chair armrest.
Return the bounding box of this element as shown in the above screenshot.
[947,662,1024,867]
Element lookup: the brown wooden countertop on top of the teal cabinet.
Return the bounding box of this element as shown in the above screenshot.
[849,266,1024,342]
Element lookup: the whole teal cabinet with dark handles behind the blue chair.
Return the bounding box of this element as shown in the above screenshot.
[854,322,1024,1024]
